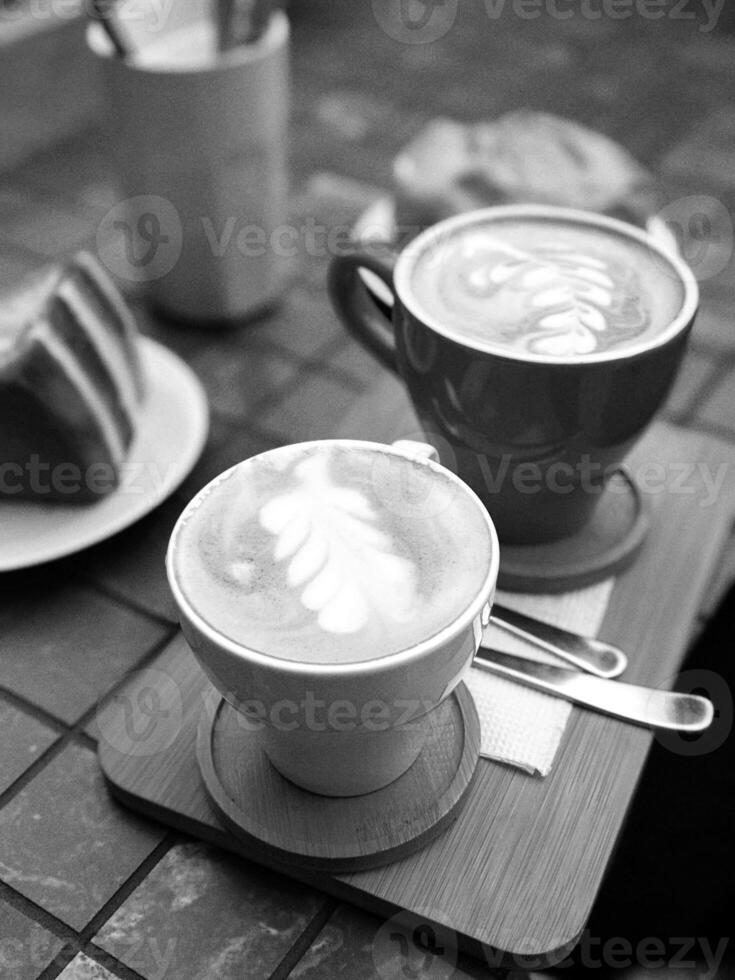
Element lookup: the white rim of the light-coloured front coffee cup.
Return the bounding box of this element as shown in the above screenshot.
[166,439,500,677]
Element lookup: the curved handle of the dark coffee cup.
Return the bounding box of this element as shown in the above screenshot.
[327,249,398,371]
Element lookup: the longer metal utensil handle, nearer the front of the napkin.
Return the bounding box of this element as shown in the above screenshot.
[474,647,714,732]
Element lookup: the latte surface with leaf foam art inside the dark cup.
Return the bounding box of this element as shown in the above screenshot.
[411,217,684,358]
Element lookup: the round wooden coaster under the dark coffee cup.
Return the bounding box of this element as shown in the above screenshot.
[498,470,651,593]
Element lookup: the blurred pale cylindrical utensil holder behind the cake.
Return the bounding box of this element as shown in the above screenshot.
[87,0,289,324]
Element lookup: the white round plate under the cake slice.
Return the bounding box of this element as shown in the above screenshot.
[0,338,209,572]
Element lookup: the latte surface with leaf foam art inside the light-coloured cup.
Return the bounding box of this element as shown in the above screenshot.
[174,442,491,663]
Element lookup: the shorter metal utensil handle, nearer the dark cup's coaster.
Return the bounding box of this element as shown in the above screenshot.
[490,603,628,678]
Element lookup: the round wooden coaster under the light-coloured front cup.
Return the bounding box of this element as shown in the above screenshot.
[197,684,480,872]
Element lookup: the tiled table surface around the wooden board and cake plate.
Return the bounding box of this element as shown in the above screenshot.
[0,2,735,980]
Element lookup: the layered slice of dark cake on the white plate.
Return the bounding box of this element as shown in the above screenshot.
[0,253,144,503]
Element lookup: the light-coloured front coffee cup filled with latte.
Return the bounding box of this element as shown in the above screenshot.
[167,440,498,796]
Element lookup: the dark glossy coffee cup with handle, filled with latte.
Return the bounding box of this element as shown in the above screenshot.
[329,205,698,546]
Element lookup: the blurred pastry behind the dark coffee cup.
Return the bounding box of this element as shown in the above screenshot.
[394,109,660,230]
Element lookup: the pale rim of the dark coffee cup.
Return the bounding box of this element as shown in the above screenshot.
[393,204,699,366]
